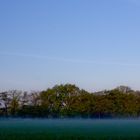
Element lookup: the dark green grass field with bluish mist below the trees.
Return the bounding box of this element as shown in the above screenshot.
[0,119,140,140]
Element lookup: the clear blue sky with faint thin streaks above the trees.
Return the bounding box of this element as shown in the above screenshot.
[0,0,140,91]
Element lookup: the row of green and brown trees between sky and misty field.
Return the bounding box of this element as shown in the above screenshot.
[0,84,140,118]
